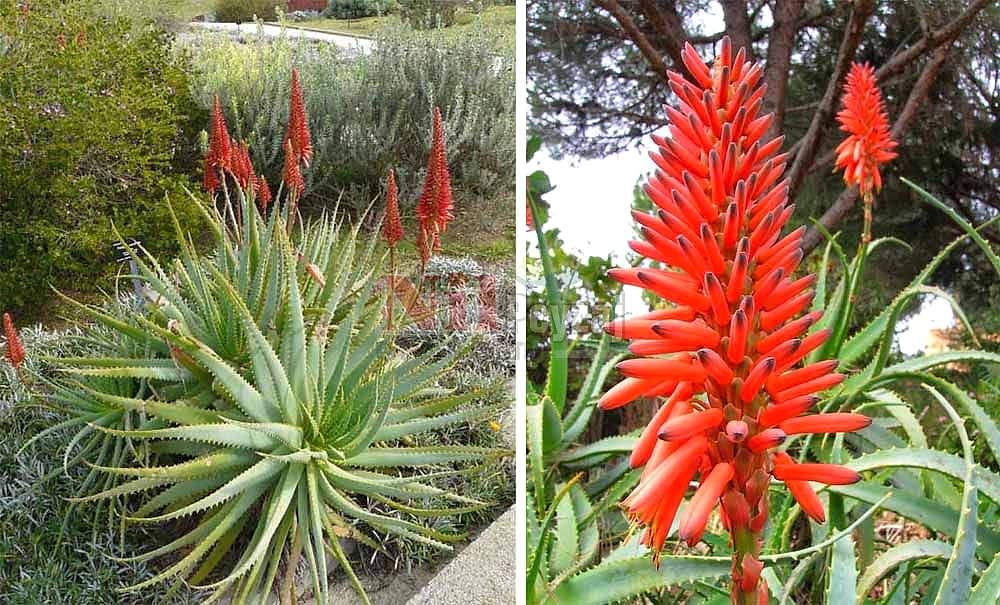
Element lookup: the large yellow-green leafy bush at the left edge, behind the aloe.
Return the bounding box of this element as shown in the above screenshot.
[0,0,205,316]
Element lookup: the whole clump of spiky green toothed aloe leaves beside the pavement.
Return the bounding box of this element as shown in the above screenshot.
[47,191,505,603]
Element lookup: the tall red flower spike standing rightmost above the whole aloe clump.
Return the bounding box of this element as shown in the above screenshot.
[417,107,454,264]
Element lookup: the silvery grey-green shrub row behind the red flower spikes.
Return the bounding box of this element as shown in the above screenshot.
[188,24,515,208]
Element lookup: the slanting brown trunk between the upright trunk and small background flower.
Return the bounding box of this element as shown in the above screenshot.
[788,0,875,203]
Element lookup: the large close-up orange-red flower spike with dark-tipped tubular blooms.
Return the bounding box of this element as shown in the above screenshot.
[599,39,867,605]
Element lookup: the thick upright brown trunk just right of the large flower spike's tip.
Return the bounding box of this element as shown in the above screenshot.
[763,0,805,139]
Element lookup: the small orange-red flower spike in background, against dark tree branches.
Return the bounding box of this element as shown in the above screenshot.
[837,63,896,197]
